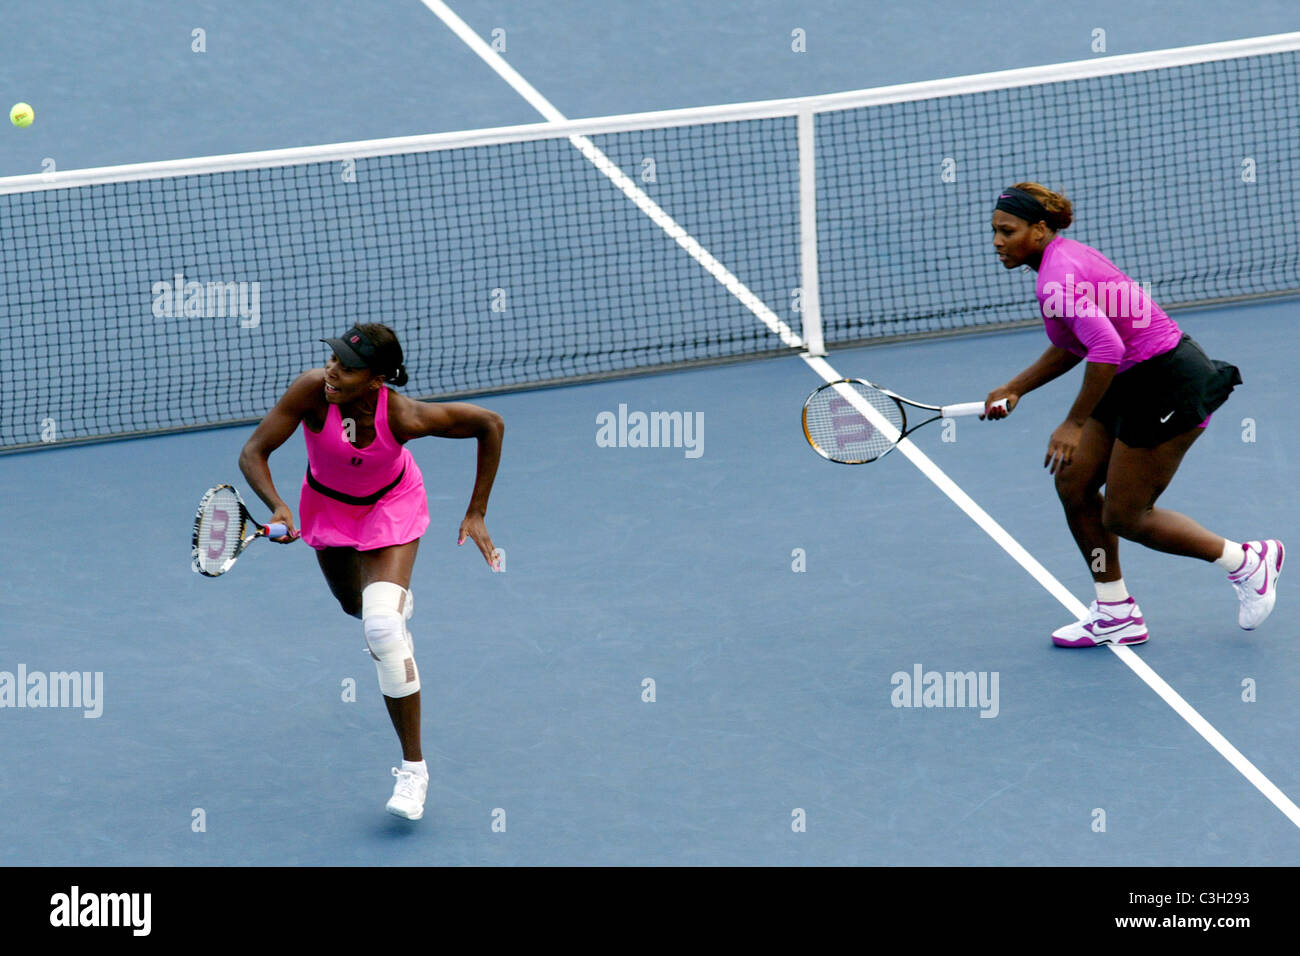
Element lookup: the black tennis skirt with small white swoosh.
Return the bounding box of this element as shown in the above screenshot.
[1092,332,1242,449]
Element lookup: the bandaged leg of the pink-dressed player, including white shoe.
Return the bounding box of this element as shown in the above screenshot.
[360,540,429,819]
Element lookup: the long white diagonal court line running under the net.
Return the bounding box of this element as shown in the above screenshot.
[421,0,1300,827]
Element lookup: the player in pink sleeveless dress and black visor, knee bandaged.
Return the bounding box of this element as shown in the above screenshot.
[239,324,504,819]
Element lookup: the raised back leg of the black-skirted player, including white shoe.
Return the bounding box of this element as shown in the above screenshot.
[1102,427,1286,631]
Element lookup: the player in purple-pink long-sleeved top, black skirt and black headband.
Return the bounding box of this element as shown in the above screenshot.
[985,182,1284,648]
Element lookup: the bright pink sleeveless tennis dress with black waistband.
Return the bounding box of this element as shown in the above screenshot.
[298,385,429,551]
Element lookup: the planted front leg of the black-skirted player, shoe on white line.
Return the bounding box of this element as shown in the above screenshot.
[1052,418,1147,648]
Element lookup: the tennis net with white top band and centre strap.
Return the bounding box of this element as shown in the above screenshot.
[0,34,1300,451]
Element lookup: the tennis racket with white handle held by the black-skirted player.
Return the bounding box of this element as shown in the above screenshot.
[803,378,1006,464]
